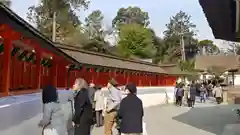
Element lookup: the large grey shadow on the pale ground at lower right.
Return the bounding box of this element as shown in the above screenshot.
[172,105,238,135]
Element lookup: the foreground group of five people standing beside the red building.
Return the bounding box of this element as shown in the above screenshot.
[38,78,144,135]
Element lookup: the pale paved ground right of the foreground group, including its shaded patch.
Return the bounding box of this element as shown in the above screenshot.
[92,97,237,135]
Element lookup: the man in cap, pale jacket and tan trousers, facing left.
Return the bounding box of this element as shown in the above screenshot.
[104,79,122,135]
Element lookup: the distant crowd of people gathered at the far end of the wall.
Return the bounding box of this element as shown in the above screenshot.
[174,81,222,108]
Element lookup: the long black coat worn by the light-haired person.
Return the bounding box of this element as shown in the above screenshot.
[73,88,93,125]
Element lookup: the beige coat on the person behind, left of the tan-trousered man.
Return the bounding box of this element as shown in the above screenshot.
[94,90,105,111]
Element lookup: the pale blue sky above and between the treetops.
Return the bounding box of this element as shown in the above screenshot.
[11,0,225,47]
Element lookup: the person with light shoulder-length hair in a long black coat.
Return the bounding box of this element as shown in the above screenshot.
[73,78,93,135]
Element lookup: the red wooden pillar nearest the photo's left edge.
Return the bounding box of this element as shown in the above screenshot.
[2,39,13,96]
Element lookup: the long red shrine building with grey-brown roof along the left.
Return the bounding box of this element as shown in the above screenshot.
[0,4,177,97]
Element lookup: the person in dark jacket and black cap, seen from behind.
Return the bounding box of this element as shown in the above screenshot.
[118,84,143,135]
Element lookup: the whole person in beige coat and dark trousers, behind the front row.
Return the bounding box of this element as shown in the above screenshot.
[94,86,104,127]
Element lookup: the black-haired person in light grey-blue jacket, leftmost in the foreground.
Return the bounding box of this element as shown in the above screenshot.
[38,85,67,135]
